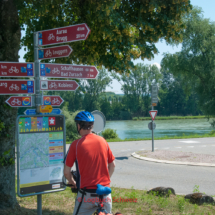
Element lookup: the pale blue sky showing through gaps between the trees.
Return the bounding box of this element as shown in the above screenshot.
[19,0,215,94]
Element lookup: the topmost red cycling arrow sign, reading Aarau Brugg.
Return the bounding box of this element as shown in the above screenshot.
[38,23,90,46]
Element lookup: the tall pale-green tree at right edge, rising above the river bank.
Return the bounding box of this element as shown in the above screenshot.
[161,8,215,116]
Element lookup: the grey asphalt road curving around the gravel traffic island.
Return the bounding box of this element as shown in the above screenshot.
[67,138,215,195]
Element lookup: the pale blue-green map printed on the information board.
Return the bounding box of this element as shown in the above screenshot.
[19,133,49,170]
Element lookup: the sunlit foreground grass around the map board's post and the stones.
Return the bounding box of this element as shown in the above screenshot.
[0,187,215,215]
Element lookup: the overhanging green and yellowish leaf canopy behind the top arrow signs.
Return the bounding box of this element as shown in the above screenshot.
[20,0,191,72]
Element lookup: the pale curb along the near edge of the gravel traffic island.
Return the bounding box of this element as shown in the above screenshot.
[131,152,215,167]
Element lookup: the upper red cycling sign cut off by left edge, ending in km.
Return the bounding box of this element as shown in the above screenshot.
[0,62,34,77]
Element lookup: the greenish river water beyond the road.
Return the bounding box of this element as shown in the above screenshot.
[105,119,213,139]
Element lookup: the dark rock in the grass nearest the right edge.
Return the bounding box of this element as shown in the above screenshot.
[184,193,215,205]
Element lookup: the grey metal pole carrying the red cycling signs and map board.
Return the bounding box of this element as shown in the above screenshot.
[34,32,42,215]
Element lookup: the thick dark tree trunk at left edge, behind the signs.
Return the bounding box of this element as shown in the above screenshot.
[0,0,21,209]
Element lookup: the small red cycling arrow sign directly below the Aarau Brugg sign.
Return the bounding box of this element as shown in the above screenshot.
[38,45,73,60]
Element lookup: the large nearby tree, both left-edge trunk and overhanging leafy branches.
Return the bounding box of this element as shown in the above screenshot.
[0,0,191,208]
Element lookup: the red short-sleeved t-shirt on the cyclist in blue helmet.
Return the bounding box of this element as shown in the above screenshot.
[65,133,115,189]
